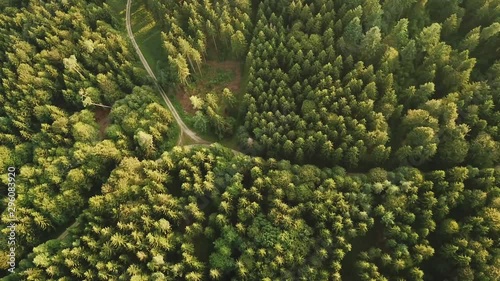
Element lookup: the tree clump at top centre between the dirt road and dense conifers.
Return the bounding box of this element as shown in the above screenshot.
[156,0,252,80]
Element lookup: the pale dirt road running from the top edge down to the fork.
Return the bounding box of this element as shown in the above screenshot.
[126,0,210,145]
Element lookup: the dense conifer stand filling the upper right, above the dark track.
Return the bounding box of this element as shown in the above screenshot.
[239,0,500,171]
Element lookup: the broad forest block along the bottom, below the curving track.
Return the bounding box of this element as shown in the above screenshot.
[16,146,500,280]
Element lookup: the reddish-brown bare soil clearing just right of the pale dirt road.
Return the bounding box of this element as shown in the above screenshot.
[176,60,241,115]
